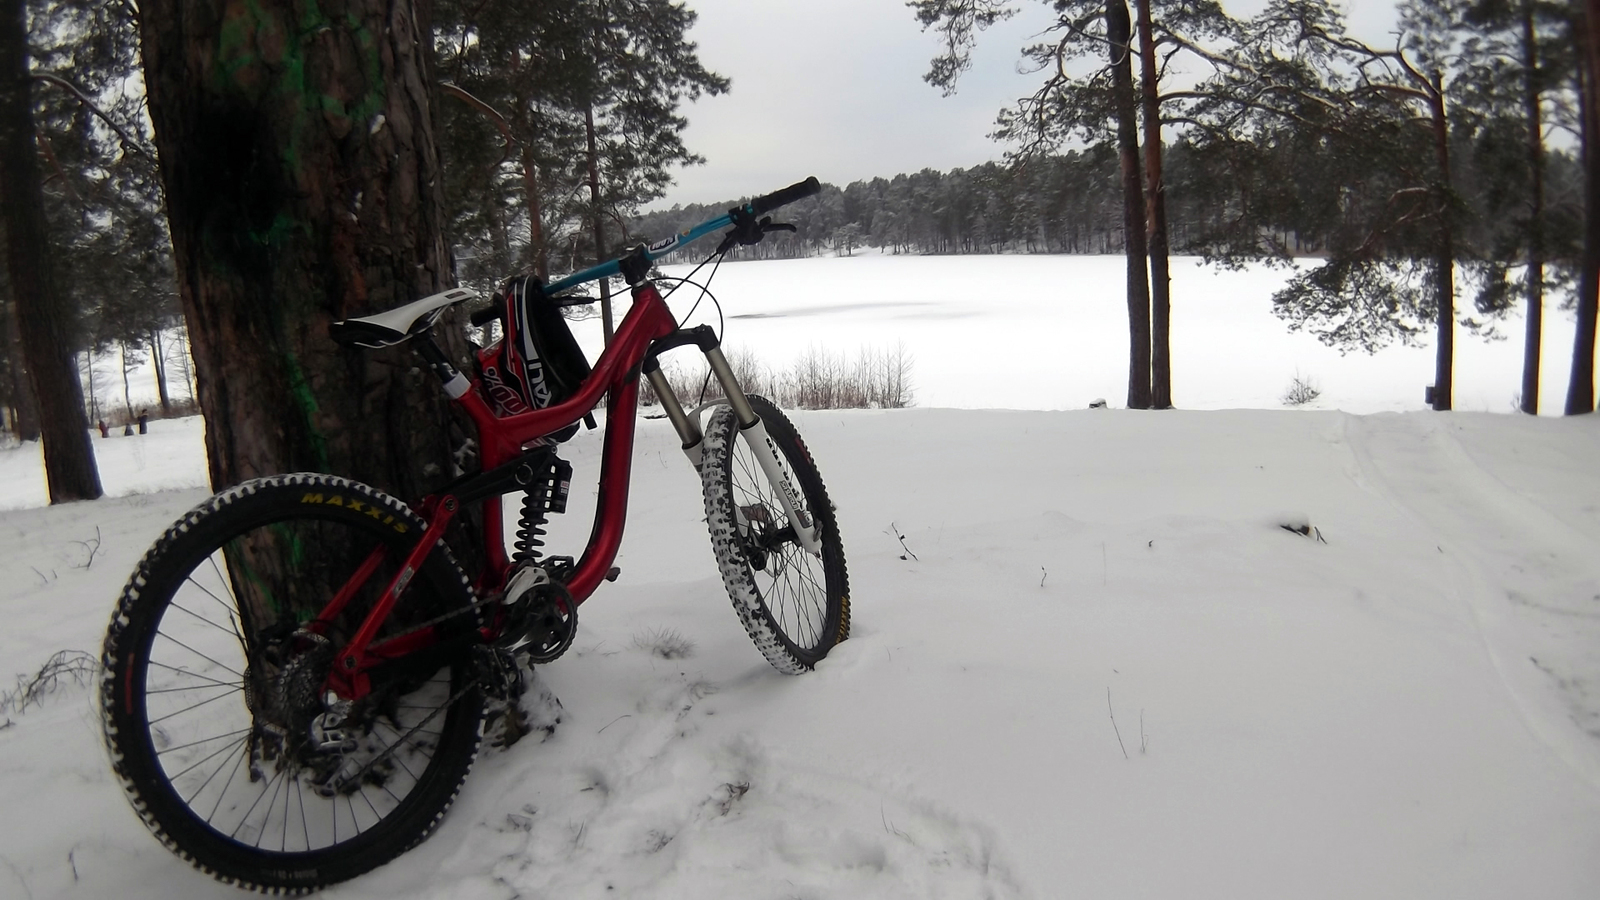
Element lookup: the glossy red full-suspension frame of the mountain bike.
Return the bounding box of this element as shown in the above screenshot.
[315,280,682,688]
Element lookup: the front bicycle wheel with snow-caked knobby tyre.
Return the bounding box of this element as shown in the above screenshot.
[701,396,850,674]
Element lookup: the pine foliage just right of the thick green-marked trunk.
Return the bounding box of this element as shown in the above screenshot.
[438,0,728,333]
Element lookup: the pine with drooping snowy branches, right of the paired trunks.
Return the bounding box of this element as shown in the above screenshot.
[1192,0,1466,410]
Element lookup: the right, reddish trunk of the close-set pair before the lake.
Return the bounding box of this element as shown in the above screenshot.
[1134,0,1173,410]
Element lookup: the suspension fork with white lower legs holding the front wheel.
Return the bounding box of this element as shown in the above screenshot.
[643,325,822,556]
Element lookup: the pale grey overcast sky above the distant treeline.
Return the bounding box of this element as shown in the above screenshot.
[658,0,1394,205]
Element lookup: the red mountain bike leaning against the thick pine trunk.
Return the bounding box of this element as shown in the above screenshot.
[101,178,850,892]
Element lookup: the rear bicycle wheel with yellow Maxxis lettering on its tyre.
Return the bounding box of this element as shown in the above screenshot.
[101,474,483,892]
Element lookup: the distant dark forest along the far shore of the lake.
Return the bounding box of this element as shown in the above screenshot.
[627,143,1582,259]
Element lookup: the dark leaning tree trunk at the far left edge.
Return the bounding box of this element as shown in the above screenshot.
[0,0,101,503]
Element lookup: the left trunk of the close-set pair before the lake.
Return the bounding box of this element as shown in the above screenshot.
[1106,0,1150,410]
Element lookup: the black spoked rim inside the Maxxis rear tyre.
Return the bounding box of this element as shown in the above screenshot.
[130,519,462,854]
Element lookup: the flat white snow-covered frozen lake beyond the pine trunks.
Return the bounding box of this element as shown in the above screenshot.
[614,253,1573,413]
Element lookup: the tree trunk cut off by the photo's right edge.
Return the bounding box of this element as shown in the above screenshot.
[1566,0,1600,415]
